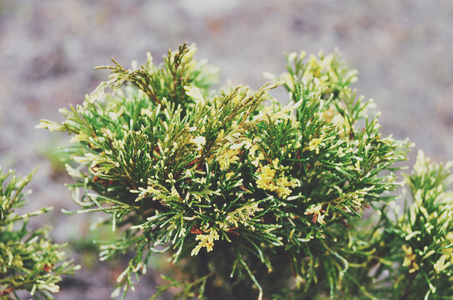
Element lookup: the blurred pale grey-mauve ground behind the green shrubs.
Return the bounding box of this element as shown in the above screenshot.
[0,0,453,299]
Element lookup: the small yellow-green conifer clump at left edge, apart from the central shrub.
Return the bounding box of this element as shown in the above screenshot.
[0,168,78,299]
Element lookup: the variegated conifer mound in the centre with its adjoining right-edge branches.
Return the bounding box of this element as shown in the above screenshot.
[39,44,453,299]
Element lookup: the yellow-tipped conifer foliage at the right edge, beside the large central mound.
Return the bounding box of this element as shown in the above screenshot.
[368,151,453,299]
